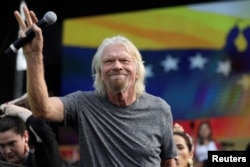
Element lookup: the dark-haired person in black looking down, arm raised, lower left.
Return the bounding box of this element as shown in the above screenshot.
[0,97,62,167]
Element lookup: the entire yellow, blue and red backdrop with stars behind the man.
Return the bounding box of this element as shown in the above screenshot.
[61,0,250,149]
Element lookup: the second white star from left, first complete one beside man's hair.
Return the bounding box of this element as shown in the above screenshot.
[161,55,179,72]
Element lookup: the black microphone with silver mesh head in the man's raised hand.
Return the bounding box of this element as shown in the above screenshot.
[4,11,57,55]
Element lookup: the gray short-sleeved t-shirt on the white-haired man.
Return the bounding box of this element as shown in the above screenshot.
[61,91,177,167]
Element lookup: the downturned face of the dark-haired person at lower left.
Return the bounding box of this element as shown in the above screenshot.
[0,129,28,164]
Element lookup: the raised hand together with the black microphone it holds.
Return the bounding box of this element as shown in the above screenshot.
[4,6,57,55]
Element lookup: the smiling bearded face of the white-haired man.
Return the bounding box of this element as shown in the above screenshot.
[102,44,137,93]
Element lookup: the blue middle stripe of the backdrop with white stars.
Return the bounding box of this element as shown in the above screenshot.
[61,47,250,120]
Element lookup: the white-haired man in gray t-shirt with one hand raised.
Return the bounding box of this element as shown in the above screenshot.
[14,7,177,167]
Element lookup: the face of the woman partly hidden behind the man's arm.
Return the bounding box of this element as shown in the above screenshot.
[174,135,193,167]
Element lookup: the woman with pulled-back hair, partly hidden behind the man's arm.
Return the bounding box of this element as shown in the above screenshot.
[174,124,194,167]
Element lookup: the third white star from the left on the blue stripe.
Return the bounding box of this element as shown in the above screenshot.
[189,53,208,70]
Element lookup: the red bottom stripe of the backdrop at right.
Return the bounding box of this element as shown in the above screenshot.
[174,116,250,139]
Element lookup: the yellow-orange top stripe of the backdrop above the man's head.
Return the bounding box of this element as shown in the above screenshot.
[63,6,249,49]
